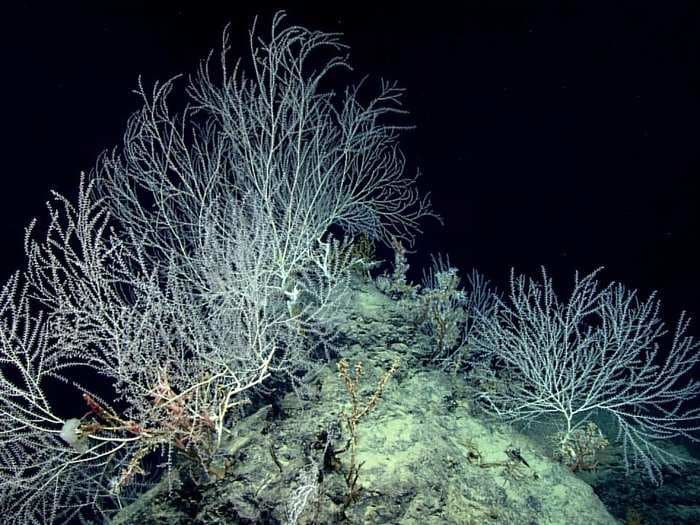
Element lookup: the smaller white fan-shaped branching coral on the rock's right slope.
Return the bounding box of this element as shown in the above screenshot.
[479,270,700,482]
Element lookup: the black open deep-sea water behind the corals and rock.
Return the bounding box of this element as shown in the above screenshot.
[0,1,700,333]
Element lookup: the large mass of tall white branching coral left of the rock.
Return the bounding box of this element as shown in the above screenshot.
[0,14,432,524]
